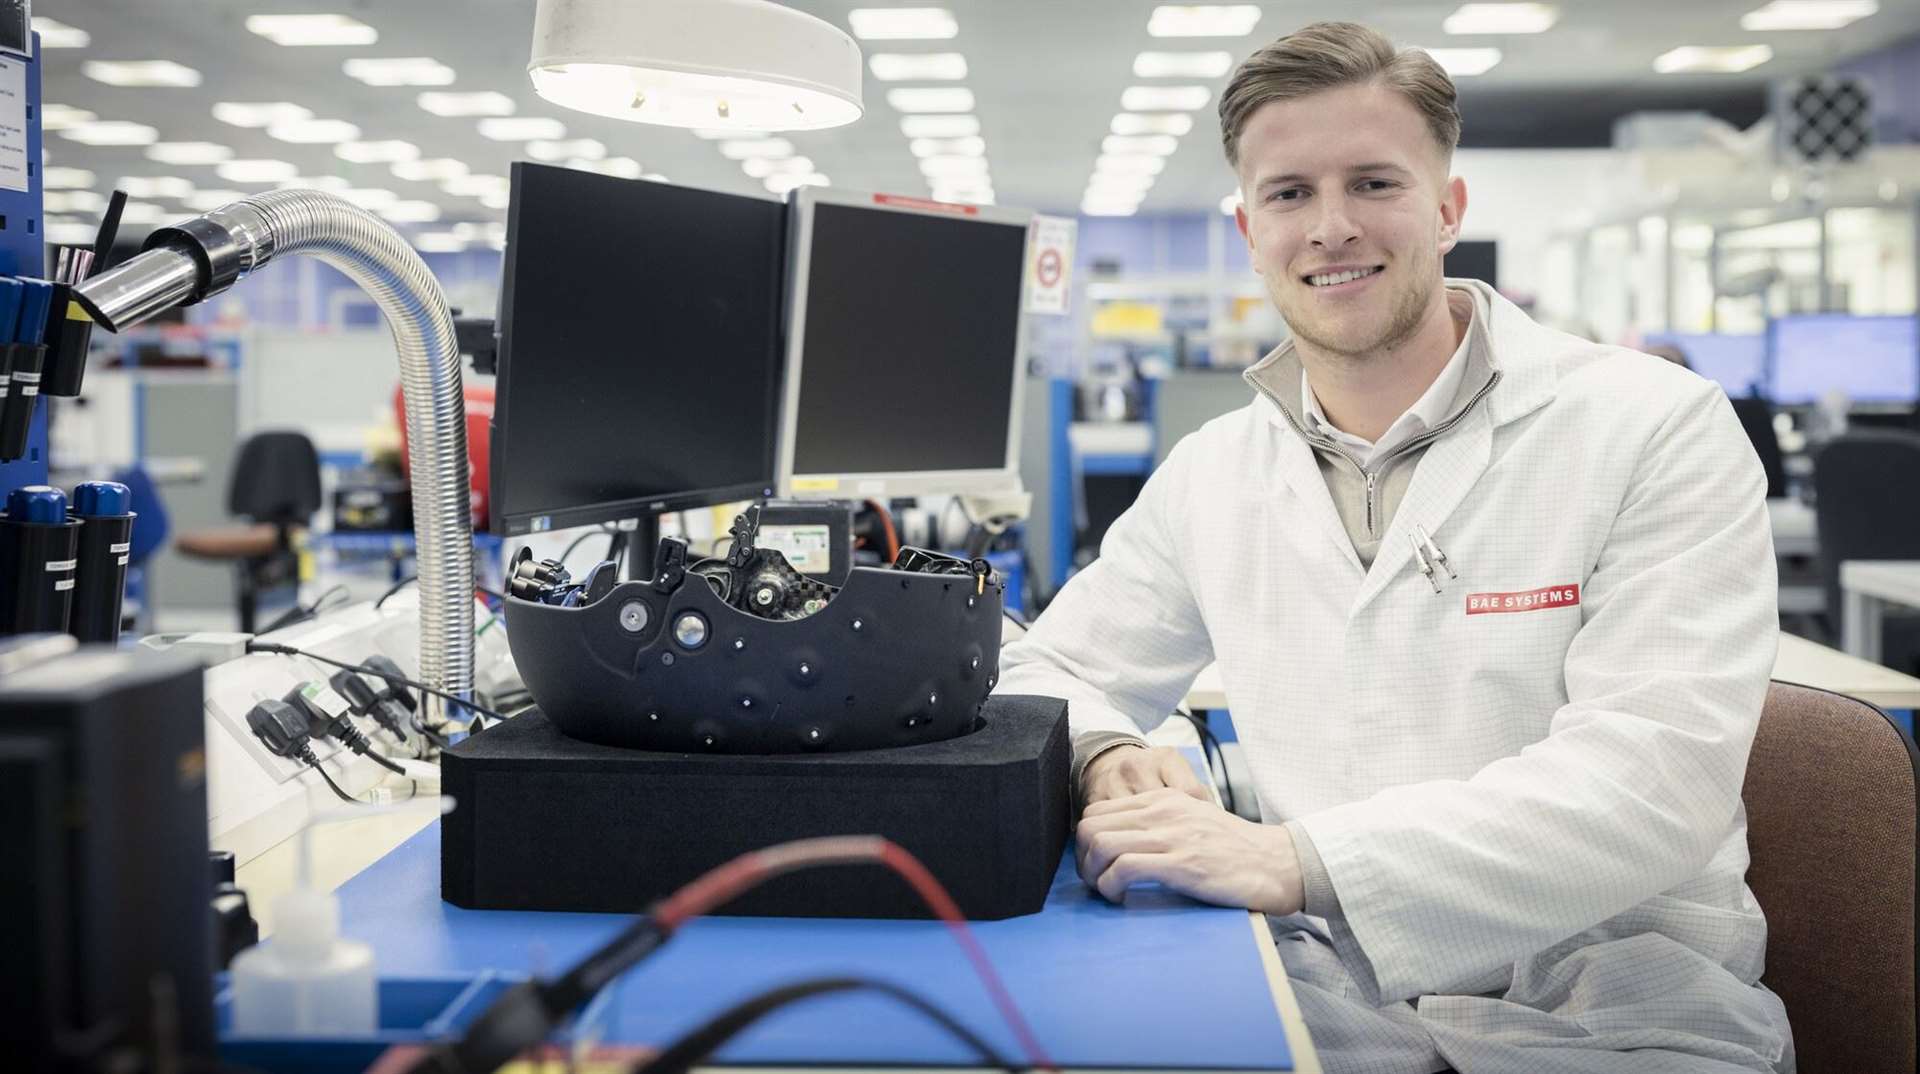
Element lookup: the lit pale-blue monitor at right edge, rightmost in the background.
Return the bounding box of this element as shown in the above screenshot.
[1766,313,1920,405]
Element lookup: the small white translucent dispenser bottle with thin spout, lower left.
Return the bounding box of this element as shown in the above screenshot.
[230,817,380,1037]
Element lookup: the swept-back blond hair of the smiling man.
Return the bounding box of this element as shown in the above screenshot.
[1219,23,1459,167]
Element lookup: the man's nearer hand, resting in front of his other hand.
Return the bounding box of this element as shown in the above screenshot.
[1077,788,1306,915]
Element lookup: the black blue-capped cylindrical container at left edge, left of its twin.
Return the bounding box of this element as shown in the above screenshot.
[0,484,81,634]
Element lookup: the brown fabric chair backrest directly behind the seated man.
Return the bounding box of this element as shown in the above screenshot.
[1741,682,1920,1074]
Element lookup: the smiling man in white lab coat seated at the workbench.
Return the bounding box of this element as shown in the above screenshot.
[998,23,1793,1074]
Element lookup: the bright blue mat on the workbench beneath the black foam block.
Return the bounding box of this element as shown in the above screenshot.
[340,822,1292,1070]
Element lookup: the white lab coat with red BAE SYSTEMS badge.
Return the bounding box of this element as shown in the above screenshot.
[998,281,1791,1070]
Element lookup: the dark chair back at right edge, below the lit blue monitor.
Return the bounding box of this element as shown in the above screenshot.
[1812,428,1920,621]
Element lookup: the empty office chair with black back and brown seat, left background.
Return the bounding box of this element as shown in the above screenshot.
[175,432,321,634]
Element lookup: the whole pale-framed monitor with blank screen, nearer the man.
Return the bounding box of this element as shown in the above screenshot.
[780,186,1033,498]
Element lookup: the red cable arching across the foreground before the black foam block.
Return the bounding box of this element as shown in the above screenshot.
[653,836,1058,1070]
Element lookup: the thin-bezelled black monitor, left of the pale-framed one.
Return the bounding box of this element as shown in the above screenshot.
[492,163,787,534]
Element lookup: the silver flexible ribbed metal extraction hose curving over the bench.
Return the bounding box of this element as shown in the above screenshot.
[75,190,474,722]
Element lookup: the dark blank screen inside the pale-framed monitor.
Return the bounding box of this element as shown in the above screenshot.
[793,204,1027,475]
